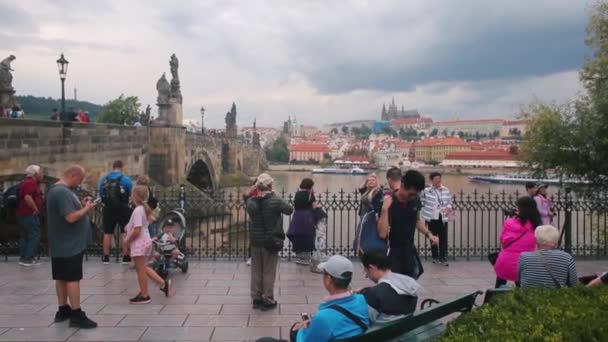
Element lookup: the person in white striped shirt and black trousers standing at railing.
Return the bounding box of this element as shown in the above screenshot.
[422,172,452,266]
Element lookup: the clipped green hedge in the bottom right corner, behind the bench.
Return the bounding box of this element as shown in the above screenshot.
[440,286,608,342]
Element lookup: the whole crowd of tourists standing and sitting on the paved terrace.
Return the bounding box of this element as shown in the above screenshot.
[8,161,608,342]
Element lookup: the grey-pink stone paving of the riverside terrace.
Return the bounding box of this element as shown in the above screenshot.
[0,260,608,341]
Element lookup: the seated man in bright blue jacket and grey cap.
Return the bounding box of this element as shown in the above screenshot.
[292,255,370,342]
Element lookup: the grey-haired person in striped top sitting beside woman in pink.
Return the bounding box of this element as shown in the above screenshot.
[517,225,578,288]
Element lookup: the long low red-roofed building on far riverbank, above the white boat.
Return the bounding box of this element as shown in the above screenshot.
[441,150,520,168]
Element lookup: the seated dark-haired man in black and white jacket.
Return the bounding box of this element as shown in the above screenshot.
[359,250,421,324]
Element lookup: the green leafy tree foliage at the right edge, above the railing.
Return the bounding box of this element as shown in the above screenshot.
[521,1,608,186]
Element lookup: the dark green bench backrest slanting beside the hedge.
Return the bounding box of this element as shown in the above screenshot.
[334,291,481,342]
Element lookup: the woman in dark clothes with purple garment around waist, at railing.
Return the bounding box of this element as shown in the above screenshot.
[287,178,319,265]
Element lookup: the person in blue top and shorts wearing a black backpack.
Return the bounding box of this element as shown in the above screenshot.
[99,160,133,265]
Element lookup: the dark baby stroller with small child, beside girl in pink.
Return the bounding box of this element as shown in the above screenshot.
[152,209,188,278]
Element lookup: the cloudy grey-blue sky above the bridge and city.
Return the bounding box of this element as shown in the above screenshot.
[0,0,589,127]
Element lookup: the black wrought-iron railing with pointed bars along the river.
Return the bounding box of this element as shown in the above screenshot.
[0,186,608,260]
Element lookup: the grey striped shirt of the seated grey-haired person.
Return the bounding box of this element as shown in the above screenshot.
[517,249,578,288]
